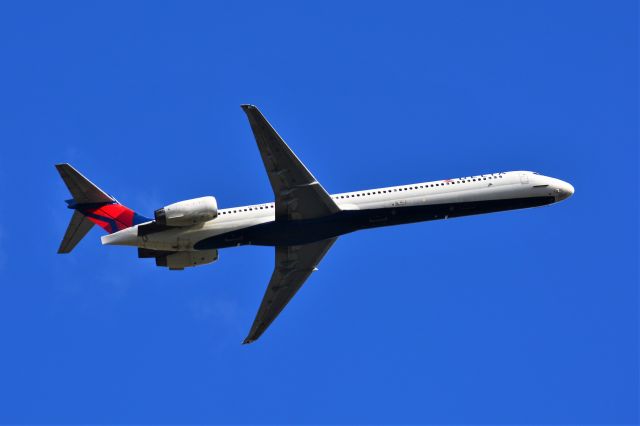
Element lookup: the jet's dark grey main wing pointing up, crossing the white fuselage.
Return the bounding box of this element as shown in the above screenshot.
[242,105,340,221]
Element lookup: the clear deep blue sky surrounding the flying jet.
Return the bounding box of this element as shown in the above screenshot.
[0,1,640,424]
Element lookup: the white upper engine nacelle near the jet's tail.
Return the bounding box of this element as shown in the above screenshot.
[153,196,218,226]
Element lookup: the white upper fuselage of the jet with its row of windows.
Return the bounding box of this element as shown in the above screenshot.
[102,171,573,251]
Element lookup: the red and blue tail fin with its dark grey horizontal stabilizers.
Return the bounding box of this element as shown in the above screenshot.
[56,163,151,253]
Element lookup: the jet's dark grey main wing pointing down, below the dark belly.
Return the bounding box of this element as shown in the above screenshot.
[243,238,337,344]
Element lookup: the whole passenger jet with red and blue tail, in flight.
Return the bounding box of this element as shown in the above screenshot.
[56,105,574,344]
